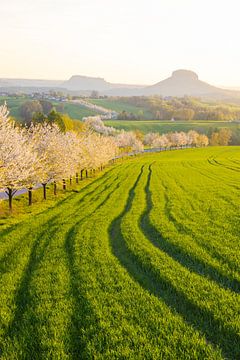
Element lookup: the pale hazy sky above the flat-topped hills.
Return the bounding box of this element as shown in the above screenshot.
[0,0,240,87]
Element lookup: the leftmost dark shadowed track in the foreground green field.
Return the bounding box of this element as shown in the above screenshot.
[1,216,58,359]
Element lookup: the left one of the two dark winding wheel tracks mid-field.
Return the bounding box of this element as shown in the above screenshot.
[109,168,240,360]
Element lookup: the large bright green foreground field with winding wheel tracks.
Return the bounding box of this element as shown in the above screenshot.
[0,147,240,360]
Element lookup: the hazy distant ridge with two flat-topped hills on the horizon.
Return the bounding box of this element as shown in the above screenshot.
[0,69,240,100]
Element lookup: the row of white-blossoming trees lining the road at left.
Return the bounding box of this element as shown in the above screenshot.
[0,105,118,209]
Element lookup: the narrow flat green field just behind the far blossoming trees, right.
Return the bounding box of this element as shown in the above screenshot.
[105,120,240,134]
